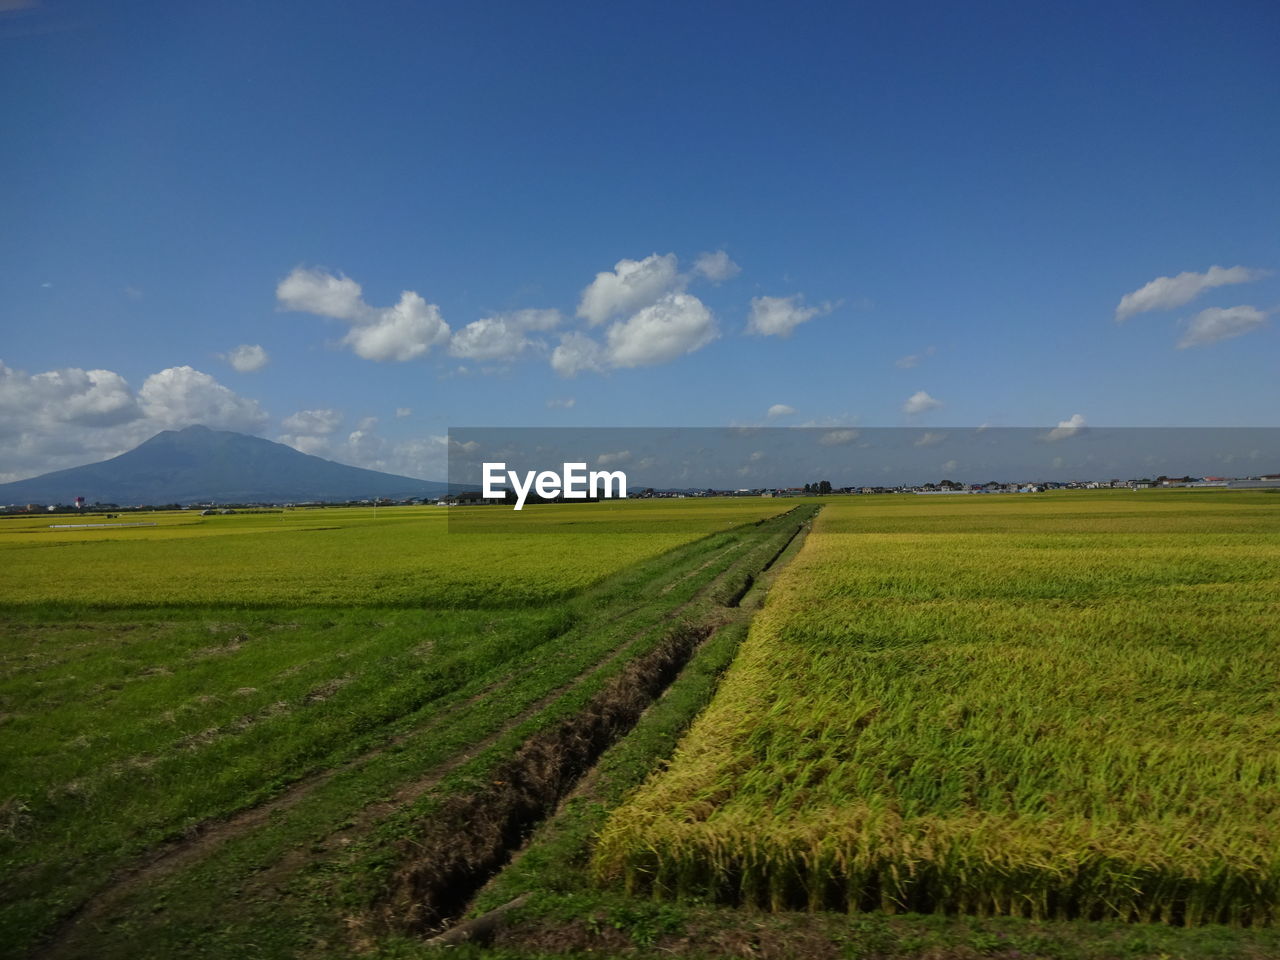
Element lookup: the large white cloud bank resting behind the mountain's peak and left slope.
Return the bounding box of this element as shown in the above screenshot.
[0,362,266,483]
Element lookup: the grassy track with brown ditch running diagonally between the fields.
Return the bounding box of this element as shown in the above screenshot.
[32,504,817,960]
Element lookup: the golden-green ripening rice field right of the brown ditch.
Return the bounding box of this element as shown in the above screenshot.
[595,492,1280,924]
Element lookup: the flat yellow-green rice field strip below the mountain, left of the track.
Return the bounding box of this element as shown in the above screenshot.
[0,500,781,608]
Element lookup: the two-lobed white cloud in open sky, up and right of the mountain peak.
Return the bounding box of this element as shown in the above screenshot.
[275,266,449,362]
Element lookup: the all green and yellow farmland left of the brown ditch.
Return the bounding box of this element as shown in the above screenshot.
[0,500,796,956]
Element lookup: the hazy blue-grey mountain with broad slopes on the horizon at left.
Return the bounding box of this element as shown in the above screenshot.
[0,426,458,506]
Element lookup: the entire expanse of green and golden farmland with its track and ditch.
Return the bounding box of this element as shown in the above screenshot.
[0,492,1280,960]
